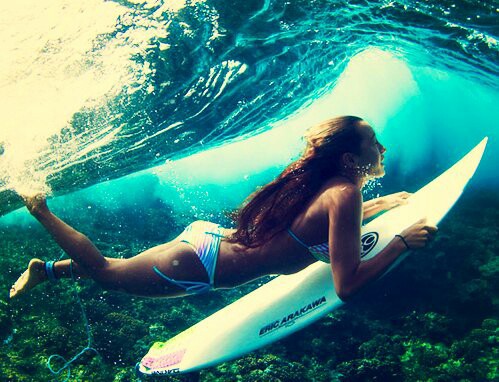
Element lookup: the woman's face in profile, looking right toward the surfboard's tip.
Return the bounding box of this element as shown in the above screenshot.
[354,121,386,178]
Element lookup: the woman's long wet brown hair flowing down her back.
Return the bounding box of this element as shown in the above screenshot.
[229,116,362,248]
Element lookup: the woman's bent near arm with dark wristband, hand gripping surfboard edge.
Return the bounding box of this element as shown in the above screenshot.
[329,186,437,300]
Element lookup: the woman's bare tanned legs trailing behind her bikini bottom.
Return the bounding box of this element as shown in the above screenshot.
[11,196,206,297]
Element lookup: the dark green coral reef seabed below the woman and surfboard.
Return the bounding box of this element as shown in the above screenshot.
[0,192,499,382]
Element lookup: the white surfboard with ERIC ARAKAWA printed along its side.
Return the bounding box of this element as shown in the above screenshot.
[136,138,487,375]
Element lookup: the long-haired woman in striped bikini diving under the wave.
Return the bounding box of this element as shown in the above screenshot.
[10,116,437,300]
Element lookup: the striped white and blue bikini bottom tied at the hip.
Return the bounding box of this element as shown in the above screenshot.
[153,220,225,293]
